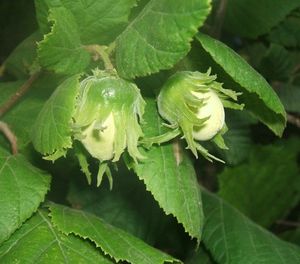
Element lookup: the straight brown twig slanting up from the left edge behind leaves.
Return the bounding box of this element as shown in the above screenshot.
[0,72,40,117]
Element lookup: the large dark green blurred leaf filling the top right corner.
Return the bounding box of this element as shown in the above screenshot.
[224,0,300,38]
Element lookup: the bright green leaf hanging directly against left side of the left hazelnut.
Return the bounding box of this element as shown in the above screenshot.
[31,75,80,155]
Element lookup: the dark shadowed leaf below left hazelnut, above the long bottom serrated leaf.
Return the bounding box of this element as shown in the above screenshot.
[68,166,165,244]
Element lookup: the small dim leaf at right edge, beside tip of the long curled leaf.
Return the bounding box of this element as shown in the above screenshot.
[277,84,300,114]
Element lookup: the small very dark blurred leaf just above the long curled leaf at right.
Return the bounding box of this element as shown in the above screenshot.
[260,44,294,81]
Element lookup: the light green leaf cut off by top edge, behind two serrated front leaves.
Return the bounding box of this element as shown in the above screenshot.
[35,0,137,44]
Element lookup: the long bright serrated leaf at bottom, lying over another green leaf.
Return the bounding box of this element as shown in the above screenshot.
[50,204,177,264]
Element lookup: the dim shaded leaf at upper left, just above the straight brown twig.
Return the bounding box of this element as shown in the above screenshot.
[4,31,42,79]
